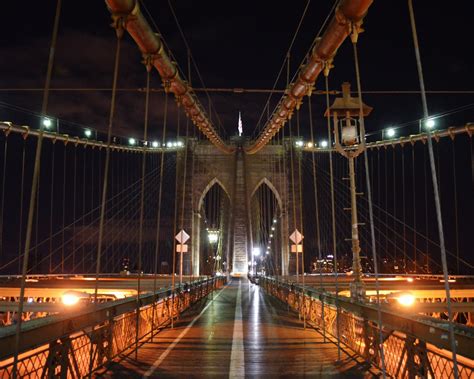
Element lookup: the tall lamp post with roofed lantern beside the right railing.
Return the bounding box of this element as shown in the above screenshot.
[326,82,372,301]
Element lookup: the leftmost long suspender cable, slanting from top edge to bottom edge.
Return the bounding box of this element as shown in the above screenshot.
[12,0,61,378]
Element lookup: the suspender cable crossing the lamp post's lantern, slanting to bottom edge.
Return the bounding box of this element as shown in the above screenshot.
[352,35,386,378]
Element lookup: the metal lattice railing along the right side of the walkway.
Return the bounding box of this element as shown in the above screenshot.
[259,277,474,378]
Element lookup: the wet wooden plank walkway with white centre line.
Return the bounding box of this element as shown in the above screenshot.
[100,279,372,378]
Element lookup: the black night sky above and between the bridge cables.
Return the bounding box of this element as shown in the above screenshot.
[0,0,474,142]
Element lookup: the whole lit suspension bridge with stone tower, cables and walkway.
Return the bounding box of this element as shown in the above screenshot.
[0,0,474,378]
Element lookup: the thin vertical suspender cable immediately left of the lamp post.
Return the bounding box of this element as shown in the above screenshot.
[324,72,341,361]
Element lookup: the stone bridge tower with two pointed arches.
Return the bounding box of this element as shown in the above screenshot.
[177,137,301,275]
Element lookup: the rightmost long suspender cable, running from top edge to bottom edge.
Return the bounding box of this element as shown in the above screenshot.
[408,0,459,379]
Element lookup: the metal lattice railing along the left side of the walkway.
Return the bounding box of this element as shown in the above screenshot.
[0,278,225,378]
